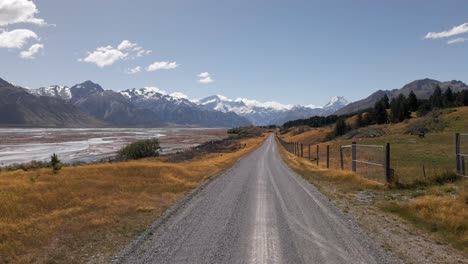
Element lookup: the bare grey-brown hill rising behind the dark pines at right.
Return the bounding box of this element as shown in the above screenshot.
[334,79,468,115]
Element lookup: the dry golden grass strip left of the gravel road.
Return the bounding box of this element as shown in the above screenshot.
[0,137,266,263]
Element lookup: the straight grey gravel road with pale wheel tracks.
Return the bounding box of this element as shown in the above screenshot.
[115,135,399,263]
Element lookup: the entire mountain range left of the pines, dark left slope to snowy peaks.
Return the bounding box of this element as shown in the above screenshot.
[0,79,347,127]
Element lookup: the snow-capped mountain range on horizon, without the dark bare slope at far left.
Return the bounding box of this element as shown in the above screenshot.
[29,81,348,127]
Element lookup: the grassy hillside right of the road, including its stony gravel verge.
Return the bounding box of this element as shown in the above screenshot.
[281,107,468,258]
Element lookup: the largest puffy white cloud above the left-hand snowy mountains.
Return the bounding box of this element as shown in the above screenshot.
[78,40,151,70]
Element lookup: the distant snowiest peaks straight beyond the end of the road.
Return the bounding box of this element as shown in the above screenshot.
[196,95,348,125]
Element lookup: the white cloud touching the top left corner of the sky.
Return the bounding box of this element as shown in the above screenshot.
[0,0,46,26]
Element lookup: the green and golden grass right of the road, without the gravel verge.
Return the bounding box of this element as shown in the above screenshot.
[282,107,468,254]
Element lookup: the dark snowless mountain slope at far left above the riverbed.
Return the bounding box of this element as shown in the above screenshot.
[0,79,108,127]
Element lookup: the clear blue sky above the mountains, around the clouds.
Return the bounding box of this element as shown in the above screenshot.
[0,0,468,105]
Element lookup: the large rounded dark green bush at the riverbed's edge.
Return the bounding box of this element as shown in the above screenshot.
[118,138,161,160]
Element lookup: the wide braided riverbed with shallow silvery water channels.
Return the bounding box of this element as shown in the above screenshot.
[0,128,225,166]
